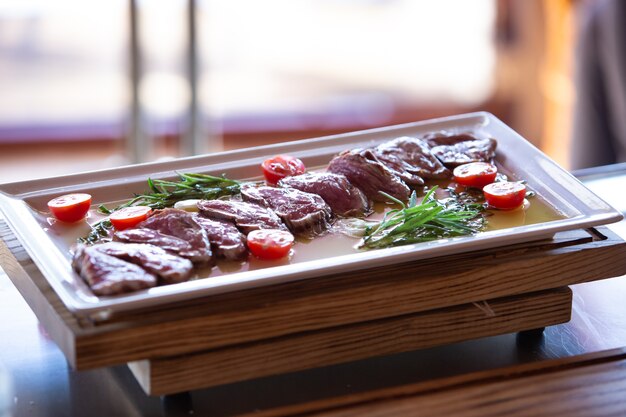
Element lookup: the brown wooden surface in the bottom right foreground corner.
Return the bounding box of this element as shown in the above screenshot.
[234,348,626,417]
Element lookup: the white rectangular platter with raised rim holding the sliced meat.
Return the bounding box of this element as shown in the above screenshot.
[0,112,622,317]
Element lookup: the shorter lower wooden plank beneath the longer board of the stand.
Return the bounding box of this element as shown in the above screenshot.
[129,287,572,395]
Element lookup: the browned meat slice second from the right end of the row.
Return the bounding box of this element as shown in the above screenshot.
[373,136,452,180]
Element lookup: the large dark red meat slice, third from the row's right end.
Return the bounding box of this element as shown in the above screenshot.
[328,149,411,201]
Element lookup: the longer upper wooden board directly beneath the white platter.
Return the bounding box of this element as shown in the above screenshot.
[0,222,626,369]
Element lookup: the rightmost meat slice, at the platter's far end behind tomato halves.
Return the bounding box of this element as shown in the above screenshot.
[427,134,497,168]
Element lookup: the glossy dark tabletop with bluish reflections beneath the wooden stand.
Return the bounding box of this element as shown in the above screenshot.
[0,165,626,417]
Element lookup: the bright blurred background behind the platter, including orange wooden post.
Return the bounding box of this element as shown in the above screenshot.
[0,0,587,182]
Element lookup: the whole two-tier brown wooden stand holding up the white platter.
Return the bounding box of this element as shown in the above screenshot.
[0,222,626,394]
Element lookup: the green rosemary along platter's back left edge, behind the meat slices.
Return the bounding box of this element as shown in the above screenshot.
[78,173,240,244]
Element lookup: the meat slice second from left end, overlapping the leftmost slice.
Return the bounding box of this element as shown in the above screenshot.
[93,242,193,284]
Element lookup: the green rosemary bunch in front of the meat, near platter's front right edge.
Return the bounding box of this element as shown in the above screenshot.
[359,187,484,249]
